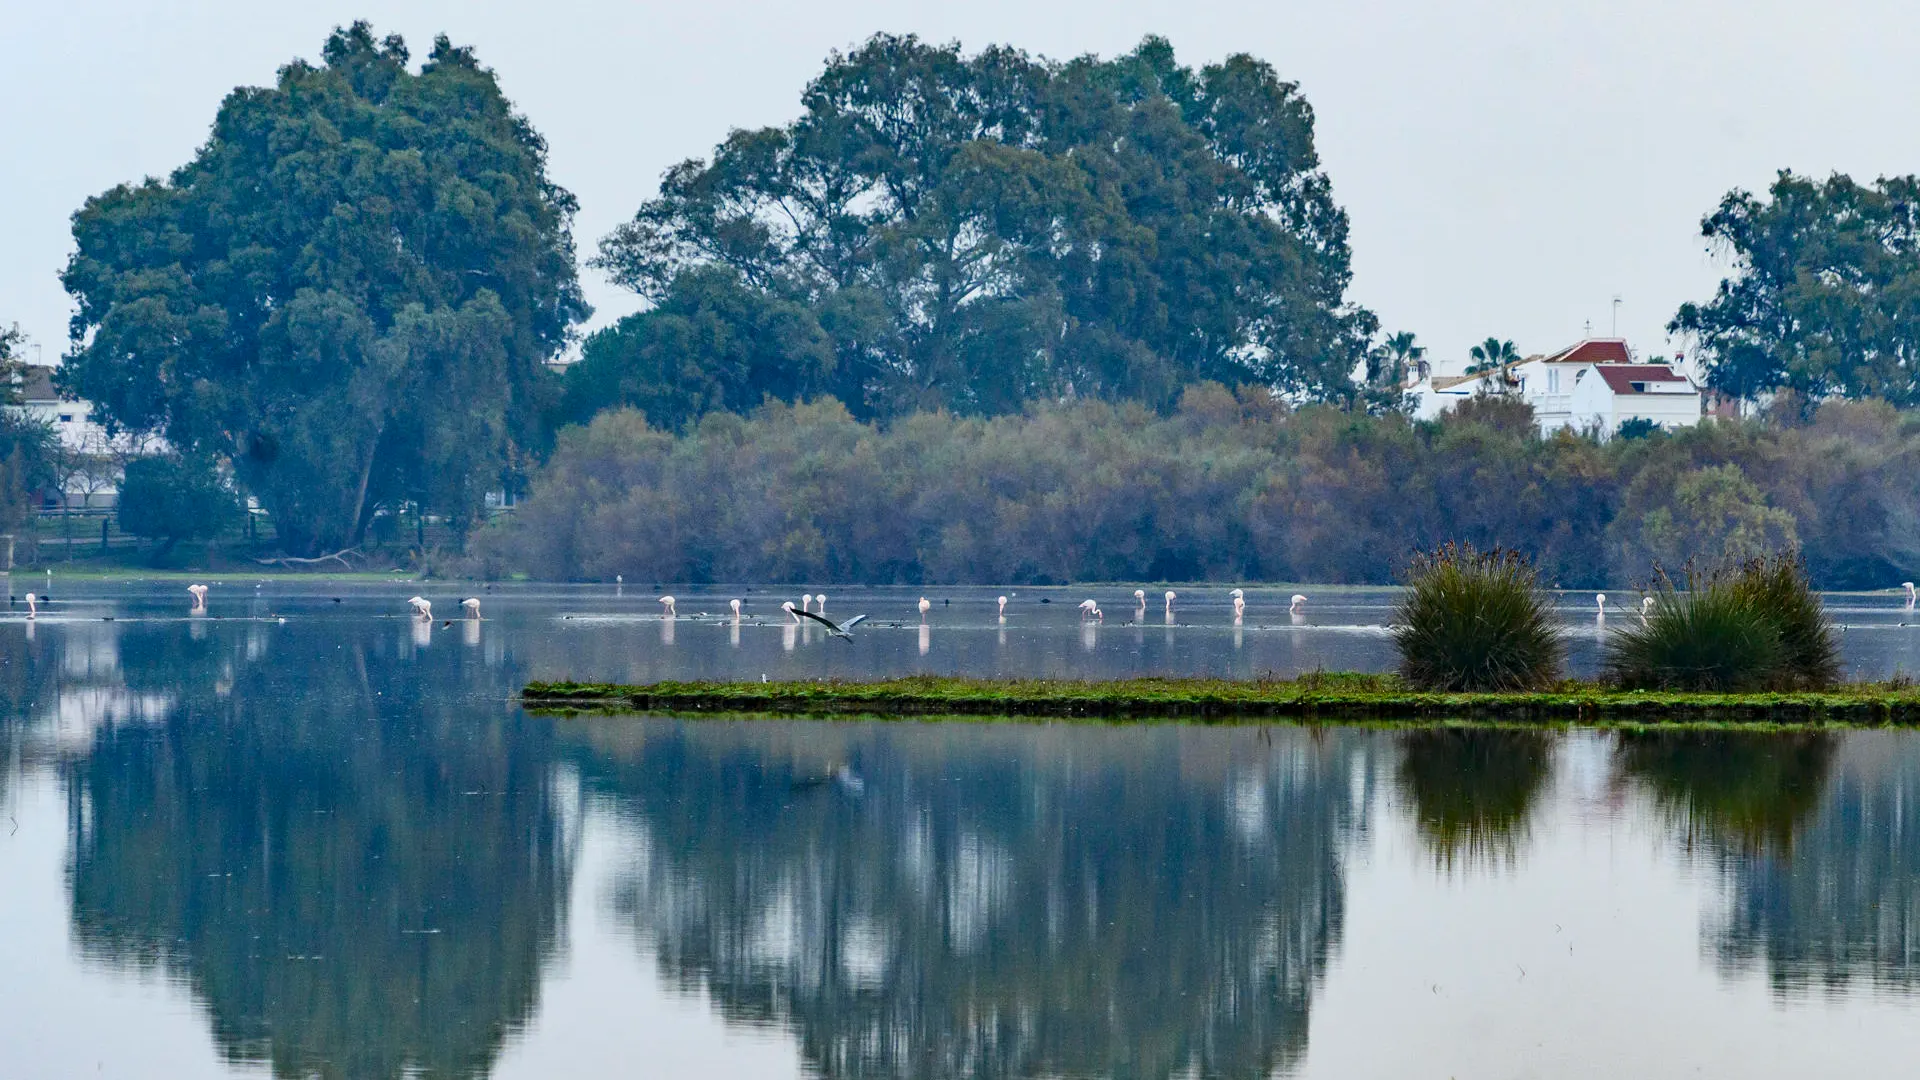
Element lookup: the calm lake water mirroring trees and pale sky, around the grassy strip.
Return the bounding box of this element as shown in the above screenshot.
[0,575,1920,1078]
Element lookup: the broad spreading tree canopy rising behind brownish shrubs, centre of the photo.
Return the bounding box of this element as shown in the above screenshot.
[576,35,1377,425]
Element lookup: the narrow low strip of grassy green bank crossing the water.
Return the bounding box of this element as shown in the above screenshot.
[520,673,1920,724]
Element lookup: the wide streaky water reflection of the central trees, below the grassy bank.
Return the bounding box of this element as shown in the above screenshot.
[560,721,1371,1076]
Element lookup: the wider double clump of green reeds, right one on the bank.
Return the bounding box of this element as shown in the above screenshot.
[1605,555,1839,692]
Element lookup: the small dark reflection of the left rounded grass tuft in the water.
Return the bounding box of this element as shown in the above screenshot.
[1398,726,1553,869]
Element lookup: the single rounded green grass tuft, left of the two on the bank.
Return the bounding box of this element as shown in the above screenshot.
[1394,544,1567,690]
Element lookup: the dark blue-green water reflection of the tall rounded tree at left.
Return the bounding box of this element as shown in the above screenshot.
[65,625,570,1076]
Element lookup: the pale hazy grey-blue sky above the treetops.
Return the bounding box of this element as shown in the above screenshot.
[0,0,1920,376]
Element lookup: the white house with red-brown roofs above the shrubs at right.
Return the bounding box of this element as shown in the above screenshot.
[1411,338,1701,438]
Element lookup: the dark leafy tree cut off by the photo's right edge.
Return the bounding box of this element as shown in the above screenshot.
[1668,171,1920,405]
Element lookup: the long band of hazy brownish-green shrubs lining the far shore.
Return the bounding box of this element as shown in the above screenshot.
[480,384,1920,588]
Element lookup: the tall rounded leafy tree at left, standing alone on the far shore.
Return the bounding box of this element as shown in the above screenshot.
[63,23,588,553]
